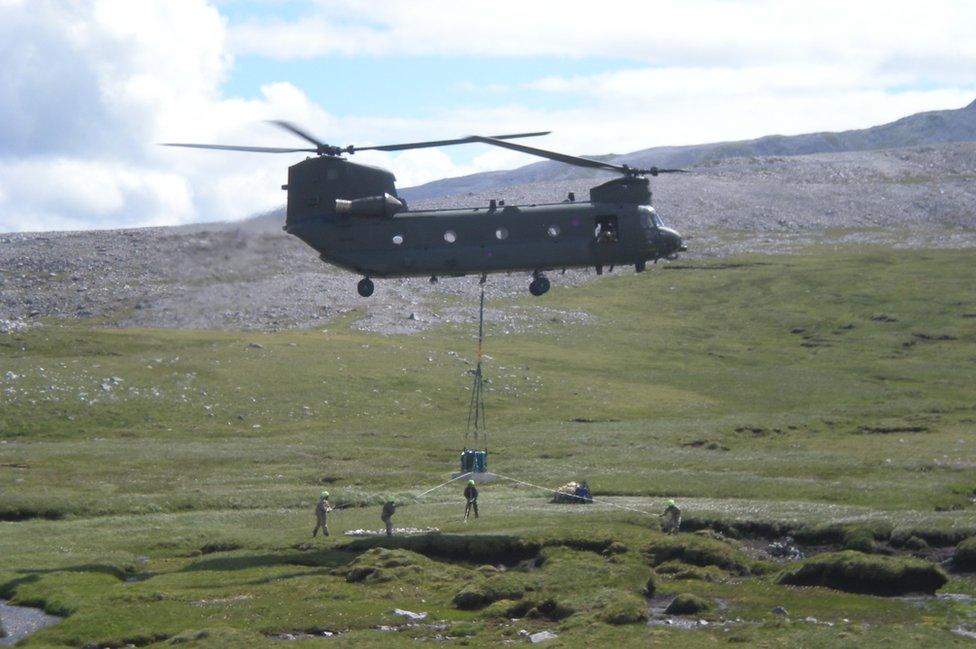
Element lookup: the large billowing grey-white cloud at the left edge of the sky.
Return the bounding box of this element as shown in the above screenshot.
[0,0,234,230]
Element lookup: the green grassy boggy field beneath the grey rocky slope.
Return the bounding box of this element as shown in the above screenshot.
[0,247,976,646]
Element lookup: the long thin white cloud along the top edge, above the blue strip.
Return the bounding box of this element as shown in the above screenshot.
[230,0,976,74]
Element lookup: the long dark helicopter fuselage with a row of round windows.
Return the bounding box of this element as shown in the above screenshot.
[287,202,681,278]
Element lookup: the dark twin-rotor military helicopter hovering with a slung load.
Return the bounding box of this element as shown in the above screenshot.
[164,121,687,297]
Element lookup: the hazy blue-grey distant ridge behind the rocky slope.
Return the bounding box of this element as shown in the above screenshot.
[398,101,976,201]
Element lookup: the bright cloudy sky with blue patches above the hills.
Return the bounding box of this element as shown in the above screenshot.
[0,0,976,232]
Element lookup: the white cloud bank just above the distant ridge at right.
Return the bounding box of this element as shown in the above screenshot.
[529,66,976,147]
